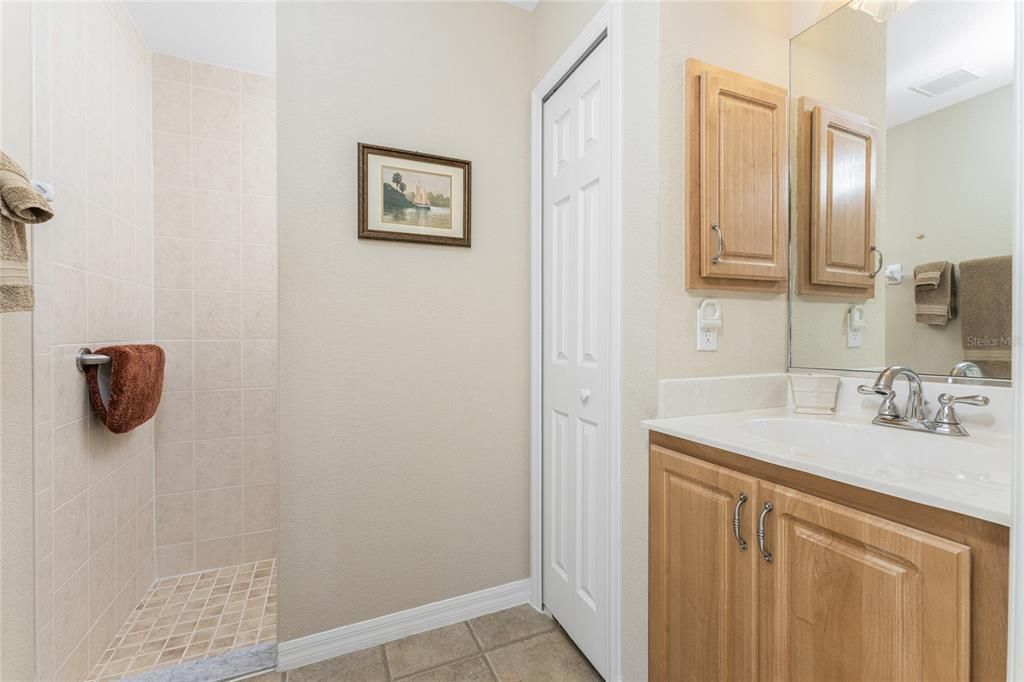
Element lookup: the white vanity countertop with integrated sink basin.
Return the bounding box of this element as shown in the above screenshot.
[643,407,1013,525]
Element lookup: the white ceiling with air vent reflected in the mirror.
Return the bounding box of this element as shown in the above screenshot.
[886,0,1014,128]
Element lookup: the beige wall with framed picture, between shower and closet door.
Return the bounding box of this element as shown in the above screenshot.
[278,2,532,641]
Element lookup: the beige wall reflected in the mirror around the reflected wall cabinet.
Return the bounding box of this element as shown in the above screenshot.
[790,8,894,369]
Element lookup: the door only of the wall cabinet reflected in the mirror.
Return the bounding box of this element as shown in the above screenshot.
[810,106,878,289]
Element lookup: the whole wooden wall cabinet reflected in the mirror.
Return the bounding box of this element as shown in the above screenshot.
[798,97,882,298]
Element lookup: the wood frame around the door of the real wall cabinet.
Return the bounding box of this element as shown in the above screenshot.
[685,59,790,294]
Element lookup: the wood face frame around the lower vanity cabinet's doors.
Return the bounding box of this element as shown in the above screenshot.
[649,431,1010,681]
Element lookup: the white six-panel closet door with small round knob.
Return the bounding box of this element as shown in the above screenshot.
[543,35,611,675]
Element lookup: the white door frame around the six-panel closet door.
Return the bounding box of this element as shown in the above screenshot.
[529,0,623,681]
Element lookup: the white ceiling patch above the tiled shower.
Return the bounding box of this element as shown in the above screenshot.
[125,0,278,76]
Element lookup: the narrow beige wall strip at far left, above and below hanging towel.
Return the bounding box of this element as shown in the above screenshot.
[0,3,35,680]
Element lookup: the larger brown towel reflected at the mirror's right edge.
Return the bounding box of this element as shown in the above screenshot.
[959,256,1014,379]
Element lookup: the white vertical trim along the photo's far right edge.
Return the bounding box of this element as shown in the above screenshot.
[1007,2,1024,680]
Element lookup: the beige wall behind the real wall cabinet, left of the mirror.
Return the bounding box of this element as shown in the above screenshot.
[649,2,791,378]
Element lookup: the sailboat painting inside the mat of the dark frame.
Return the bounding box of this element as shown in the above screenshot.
[381,166,452,229]
